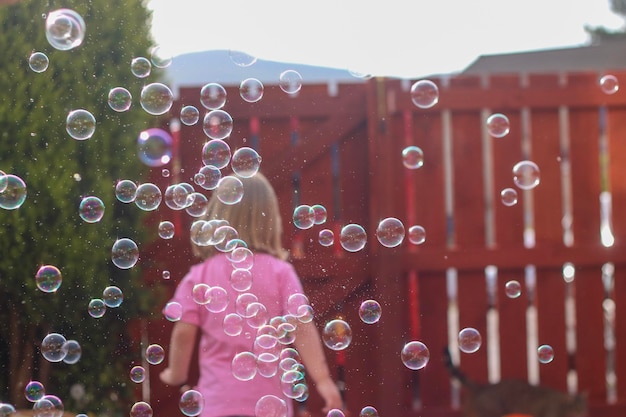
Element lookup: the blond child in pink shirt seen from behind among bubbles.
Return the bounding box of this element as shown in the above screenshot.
[160,174,342,417]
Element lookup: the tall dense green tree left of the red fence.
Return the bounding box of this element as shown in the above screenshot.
[0,0,158,414]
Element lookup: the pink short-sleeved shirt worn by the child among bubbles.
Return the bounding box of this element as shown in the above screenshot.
[171,253,302,417]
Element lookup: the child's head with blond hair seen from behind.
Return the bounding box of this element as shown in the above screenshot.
[192,173,287,259]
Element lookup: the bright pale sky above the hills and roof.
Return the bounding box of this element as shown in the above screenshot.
[147,0,624,78]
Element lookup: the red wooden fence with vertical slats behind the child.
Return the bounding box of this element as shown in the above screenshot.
[140,72,626,417]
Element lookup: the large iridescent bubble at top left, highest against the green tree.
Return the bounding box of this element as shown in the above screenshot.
[46,9,85,51]
